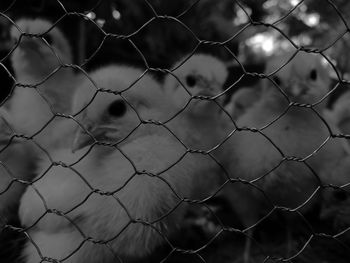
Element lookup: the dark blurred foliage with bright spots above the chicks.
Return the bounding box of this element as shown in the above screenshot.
[0,0,350,101]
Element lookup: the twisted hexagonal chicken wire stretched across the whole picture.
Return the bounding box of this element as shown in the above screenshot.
[0,0,350,262]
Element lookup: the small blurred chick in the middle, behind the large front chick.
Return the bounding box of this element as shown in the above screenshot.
[164,54,228,153]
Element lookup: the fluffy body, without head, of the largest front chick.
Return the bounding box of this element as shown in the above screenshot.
[21,135,216,263]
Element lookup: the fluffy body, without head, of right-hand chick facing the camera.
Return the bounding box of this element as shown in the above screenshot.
[229,101,340,214]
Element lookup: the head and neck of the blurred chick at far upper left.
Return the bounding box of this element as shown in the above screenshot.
[11,19,75,113]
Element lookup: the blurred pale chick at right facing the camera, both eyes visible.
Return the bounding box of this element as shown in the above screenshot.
[223,52,346,262]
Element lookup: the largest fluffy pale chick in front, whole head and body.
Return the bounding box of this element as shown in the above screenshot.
[19,66,219,263]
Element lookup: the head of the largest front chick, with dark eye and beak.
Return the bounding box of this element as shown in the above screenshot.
[73,65,171,150]
